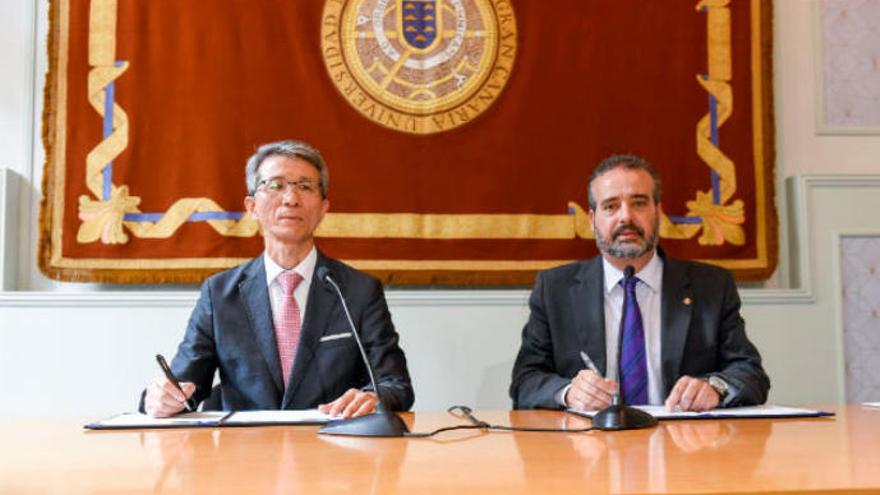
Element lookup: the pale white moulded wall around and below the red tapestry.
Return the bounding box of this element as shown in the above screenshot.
[0,0,880,417]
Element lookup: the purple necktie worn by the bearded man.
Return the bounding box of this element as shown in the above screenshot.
[620,277,648,406]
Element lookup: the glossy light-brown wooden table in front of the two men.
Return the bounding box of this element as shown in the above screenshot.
[0,405,880,495]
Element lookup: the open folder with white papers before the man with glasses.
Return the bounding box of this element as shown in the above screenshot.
[85,409,339,430]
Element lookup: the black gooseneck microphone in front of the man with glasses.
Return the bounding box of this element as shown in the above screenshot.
[315,266,409,437]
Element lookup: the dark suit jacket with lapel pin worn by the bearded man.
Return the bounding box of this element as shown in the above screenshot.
[510,252,770,409]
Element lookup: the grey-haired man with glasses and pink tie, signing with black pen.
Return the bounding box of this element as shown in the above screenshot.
[141,141,413,417]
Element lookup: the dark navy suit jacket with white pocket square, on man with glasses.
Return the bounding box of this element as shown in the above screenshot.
[147,252,414,410]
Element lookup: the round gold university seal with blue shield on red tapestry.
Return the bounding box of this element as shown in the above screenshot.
[321,0,517,134]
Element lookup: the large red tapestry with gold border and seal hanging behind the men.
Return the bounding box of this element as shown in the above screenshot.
[40,0,777,285]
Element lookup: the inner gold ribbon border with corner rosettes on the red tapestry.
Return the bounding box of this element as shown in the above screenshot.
[77,0,745,245]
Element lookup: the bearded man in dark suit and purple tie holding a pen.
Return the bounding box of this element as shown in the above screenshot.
[510,155,770,411]
